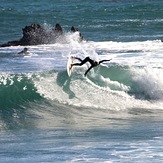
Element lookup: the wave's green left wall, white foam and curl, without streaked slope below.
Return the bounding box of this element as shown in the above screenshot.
[0,64,163,109]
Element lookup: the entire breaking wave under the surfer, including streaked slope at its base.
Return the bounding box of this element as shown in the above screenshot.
[0,64,163,130]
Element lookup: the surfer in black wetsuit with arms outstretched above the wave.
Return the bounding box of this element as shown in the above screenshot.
[71,57,111,76]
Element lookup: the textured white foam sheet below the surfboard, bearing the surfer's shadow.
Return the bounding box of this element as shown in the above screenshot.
[34,69,162,111]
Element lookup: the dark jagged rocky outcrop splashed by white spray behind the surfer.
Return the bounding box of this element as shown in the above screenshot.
[0,23,83,47]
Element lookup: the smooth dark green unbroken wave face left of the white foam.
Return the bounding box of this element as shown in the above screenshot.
[0,74,40,108]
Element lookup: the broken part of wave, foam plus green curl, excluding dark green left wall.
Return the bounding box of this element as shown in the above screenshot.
[34,64,163,110]
